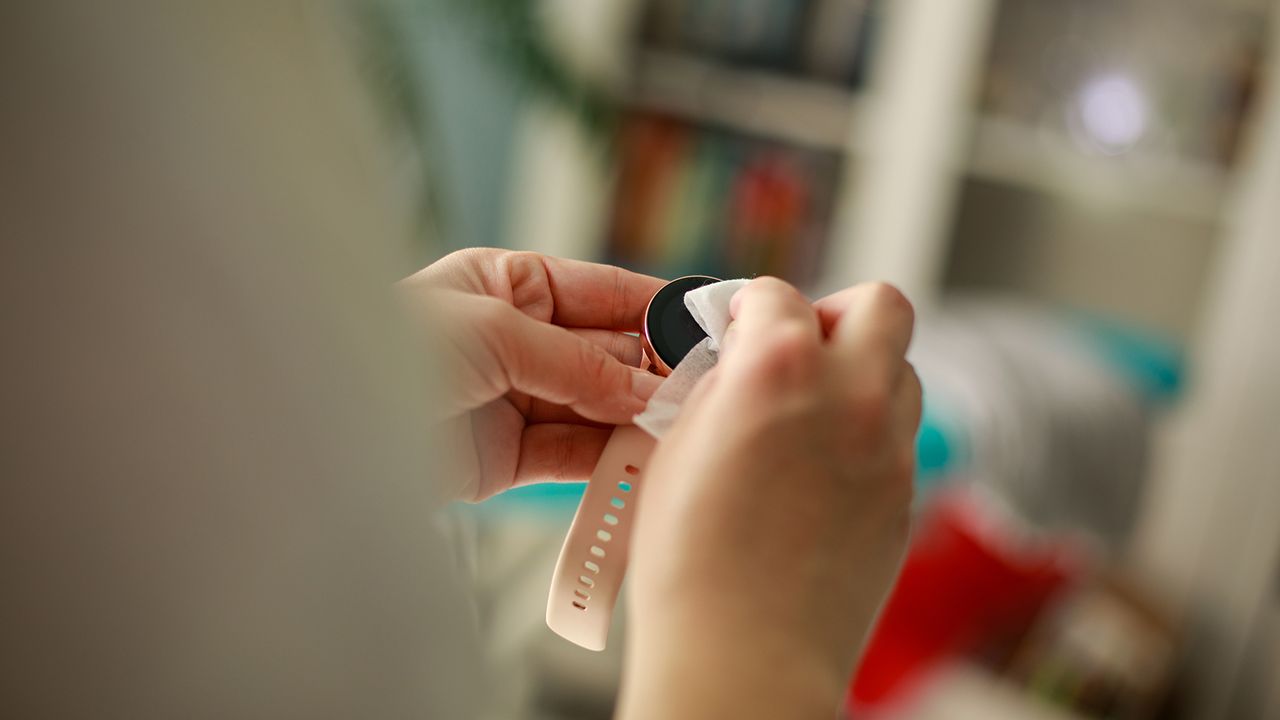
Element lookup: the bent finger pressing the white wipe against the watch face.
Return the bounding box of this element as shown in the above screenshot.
[721,277,822,356]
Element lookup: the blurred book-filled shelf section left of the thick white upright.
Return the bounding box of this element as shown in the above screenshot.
[604,0,877,288]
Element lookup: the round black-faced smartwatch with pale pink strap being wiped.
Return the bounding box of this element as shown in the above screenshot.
[547,275,721,650]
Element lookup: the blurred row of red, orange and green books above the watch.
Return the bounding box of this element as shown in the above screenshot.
[608,111,841,284]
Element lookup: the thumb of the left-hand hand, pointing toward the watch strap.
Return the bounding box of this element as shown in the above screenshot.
[476,299,662,423]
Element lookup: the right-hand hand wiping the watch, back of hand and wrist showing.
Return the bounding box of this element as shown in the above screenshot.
[622,278,920,719]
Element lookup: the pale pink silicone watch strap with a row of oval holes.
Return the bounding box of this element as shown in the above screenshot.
[547,425,657,650]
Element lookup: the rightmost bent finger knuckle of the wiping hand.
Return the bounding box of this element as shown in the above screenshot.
[814,283,915,382]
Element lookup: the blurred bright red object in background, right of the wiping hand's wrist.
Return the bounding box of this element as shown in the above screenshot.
[849,491,1083,710]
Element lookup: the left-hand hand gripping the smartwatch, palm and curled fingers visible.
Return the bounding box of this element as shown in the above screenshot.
[401,249,664,501]
